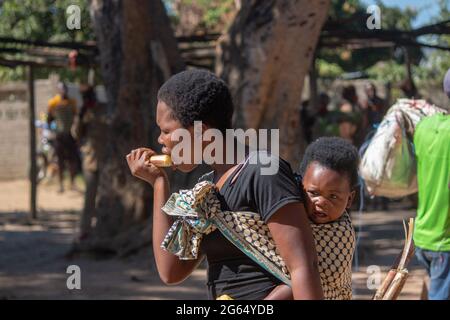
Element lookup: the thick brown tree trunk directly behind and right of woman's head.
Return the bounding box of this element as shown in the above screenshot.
[216,0,330,168]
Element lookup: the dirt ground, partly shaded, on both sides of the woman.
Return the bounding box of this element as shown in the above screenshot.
[0,180,425,300]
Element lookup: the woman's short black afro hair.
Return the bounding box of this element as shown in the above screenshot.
[158,69,234,133]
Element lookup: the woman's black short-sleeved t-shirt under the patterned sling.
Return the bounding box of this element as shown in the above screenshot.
[201,151,303,300]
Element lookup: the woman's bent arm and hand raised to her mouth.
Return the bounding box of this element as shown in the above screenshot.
[127,148,203,284]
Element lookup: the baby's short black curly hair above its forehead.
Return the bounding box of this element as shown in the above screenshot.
[300,137,359,189]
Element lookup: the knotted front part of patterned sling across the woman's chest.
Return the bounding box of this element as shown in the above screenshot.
[161,181,291,285]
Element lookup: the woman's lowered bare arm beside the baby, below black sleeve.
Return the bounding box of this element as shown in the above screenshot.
[268,202,323,300]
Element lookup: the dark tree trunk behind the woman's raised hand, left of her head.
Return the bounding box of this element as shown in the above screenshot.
[81,0,189,254]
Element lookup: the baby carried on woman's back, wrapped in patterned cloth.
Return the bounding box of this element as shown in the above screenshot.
[266,137,359,300]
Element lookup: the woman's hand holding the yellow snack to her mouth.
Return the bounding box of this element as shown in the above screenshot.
[126,148,167,187]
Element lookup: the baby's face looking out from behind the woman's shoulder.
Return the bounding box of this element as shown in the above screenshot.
[303,162,355,224]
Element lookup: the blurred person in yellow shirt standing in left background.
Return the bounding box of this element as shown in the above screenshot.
[47,82,80,192]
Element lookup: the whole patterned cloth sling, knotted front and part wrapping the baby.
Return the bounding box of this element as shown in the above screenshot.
[161,181,354,299]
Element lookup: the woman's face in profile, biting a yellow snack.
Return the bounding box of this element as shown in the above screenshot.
[156,101,197,172]
